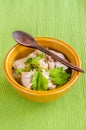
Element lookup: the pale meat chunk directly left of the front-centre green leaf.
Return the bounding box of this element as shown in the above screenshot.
[21,71,35,89]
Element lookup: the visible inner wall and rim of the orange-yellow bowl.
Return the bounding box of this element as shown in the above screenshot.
[4,38,81,95]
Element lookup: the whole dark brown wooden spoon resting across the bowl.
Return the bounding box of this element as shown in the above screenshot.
[12,31,84,73]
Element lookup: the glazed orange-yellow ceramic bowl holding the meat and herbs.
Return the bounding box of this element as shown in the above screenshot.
[4,37,81,102]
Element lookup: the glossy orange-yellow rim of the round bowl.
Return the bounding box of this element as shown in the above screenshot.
[3,37,81,96]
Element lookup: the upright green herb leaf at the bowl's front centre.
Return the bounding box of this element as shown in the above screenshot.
[32,70,48,91]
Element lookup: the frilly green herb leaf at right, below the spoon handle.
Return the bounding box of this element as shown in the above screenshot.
[50,67,70,85]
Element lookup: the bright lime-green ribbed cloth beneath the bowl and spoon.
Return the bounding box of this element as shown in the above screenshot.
[0,0,86,130]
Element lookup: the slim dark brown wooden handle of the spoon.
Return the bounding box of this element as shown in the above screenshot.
[35,44,84,73]
